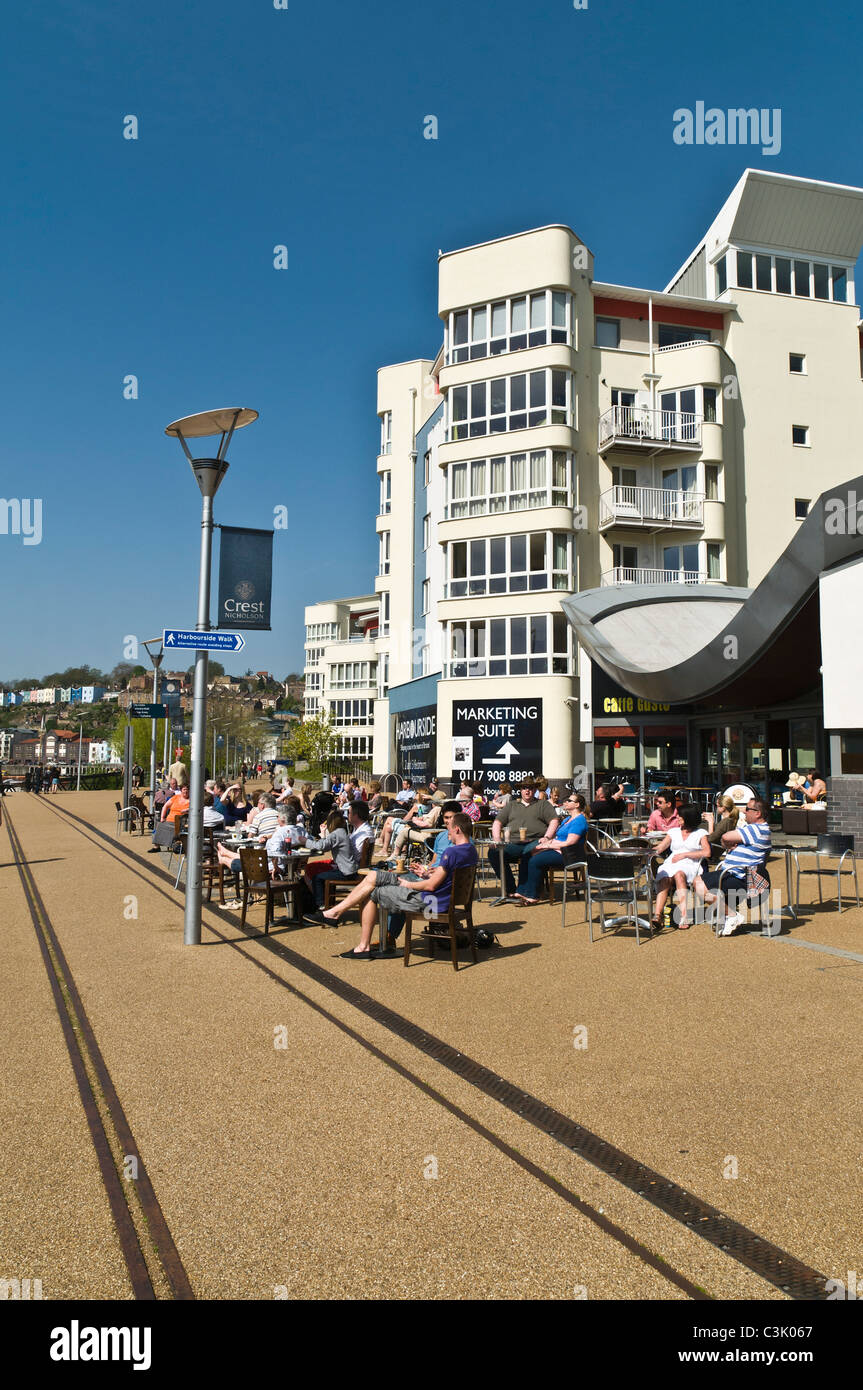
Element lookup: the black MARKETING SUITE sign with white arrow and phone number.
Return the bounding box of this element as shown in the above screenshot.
[453,699,542,787]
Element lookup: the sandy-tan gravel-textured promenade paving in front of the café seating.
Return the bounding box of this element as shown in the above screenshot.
[0,792,863,1300]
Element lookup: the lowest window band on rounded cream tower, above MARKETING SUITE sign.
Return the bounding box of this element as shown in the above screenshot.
[446,613,571,678]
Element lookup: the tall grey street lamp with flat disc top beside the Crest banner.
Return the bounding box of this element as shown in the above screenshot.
[165,406,257,947]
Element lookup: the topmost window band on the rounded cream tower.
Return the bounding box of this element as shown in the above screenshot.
[445,289,573,364]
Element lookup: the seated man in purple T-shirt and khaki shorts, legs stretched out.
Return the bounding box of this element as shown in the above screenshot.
[318,812,478,960]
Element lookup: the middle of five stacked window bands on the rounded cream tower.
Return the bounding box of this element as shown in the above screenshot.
[445,449,573,520]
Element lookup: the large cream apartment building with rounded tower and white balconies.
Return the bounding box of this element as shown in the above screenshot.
[306,170,863,785]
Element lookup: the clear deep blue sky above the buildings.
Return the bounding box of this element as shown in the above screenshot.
[0,0,863,680]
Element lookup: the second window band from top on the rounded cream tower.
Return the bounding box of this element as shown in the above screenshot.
[447,367,571,441]
